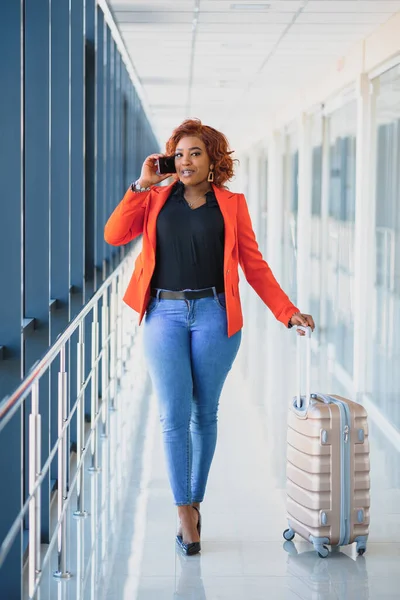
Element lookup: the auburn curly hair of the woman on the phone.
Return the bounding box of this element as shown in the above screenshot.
[165,119,238,187]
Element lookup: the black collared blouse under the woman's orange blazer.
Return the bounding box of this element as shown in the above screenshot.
[151,181,225,292]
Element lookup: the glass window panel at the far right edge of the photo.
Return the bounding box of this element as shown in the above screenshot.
[372,66,400,430]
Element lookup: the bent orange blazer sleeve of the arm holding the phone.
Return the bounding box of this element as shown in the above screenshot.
[104,189,151,246]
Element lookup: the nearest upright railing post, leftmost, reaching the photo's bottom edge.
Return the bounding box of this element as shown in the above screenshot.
[29,380,41,596]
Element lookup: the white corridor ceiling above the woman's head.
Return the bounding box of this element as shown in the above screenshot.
[108,0,400,149]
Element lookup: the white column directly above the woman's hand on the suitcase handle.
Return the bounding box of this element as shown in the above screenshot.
[297,114,312,313]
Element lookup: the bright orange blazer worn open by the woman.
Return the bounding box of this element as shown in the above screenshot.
[104,184,299,337]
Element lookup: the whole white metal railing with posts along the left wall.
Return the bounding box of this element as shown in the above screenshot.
[0,250,136,598]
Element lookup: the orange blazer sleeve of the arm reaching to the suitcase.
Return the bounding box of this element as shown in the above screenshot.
[237,194,300,327]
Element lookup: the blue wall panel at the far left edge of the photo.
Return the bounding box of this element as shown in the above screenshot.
[0,2,23,598]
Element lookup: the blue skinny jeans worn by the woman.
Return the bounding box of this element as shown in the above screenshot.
[143,288,242,506]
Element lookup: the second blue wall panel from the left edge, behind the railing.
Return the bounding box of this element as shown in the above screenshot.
[22,0,50,542]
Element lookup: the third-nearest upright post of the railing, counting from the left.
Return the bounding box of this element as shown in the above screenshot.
[74,322,88,517]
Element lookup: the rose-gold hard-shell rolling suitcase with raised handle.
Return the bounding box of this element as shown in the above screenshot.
[283,327,370,558]
